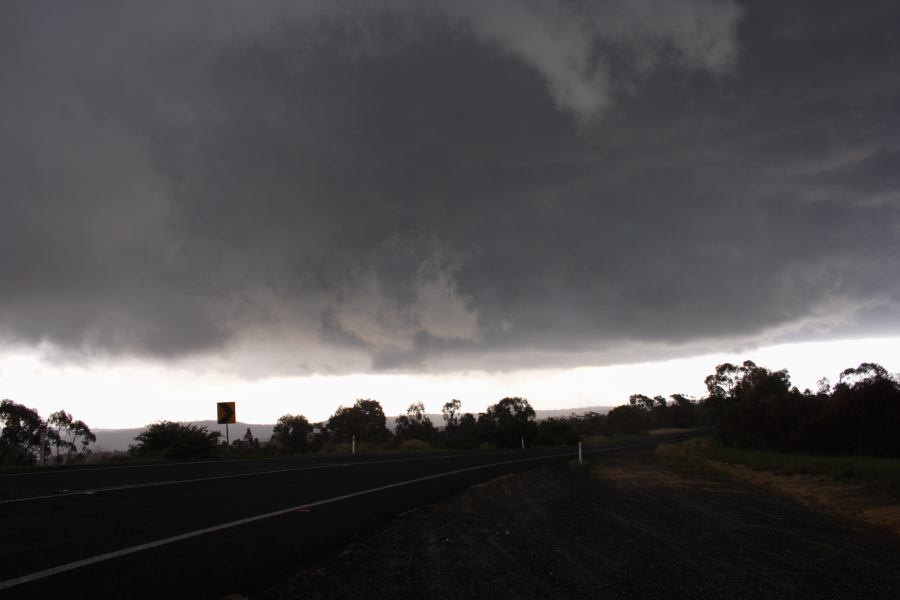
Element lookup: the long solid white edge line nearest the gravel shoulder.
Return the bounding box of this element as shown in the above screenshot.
[0,451,572,590]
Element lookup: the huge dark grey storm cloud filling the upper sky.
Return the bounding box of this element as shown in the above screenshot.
[0,0,900,372]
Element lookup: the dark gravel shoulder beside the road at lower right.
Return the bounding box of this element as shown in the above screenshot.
[253,450,900,600]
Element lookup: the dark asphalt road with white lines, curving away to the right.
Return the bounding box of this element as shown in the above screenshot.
[0,436,696,598]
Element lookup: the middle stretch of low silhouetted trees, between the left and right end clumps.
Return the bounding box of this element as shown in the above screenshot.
[131,395,700,458]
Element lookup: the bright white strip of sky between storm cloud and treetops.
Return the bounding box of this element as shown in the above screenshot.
[0,338,900,428]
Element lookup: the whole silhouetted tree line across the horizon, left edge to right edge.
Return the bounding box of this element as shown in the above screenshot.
[0,360,900,465]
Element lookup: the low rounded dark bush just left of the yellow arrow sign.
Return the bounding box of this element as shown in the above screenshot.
[128,421,222,459]
